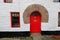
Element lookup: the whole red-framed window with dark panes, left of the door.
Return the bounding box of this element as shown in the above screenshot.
[11,12,20,27]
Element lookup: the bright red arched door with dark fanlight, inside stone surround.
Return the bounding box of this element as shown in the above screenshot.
[30,11,41,33]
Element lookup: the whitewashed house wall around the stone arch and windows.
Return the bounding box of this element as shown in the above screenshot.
[0,0,60,31]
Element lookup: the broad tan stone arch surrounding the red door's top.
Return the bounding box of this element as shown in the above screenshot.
[23,4,49,24]
